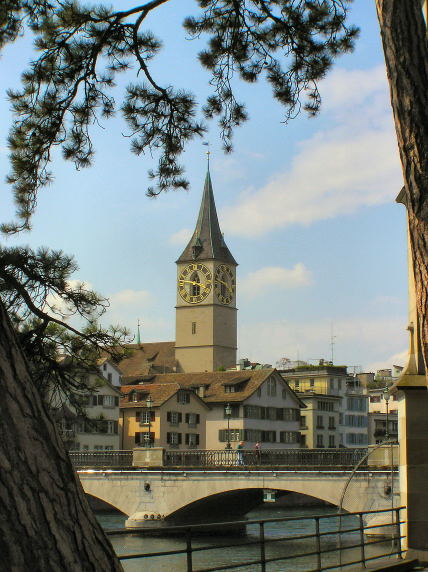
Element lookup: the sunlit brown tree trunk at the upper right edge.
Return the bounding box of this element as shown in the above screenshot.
[376,0,428,371]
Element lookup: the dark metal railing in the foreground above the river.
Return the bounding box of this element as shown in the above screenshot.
[106,507,405,572]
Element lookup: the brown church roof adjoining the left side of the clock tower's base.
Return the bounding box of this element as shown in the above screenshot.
[118,342,175,383]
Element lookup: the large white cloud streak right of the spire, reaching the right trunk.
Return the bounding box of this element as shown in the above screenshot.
[221,68,401,237]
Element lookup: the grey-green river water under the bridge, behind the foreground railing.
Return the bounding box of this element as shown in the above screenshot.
[97,503,396,572]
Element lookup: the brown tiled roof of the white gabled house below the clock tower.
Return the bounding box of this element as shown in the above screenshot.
[118,369,306,407]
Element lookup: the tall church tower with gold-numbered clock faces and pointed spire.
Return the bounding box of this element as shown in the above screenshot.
[175,169,237,373]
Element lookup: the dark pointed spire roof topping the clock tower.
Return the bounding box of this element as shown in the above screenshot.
[177,171,237,265]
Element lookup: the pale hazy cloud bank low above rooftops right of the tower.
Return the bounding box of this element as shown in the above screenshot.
[238,315,408,371]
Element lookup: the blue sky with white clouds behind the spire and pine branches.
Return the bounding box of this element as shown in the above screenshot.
[0,0,407,371]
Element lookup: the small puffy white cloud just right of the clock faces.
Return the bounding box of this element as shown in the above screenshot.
[239,262,312,297]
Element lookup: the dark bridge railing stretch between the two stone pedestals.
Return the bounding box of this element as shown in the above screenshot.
[164,448,367,467]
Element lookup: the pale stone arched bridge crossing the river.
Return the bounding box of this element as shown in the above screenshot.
[78,468,399,528]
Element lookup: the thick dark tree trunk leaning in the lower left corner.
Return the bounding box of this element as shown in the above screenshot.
[0,302,122,572]
